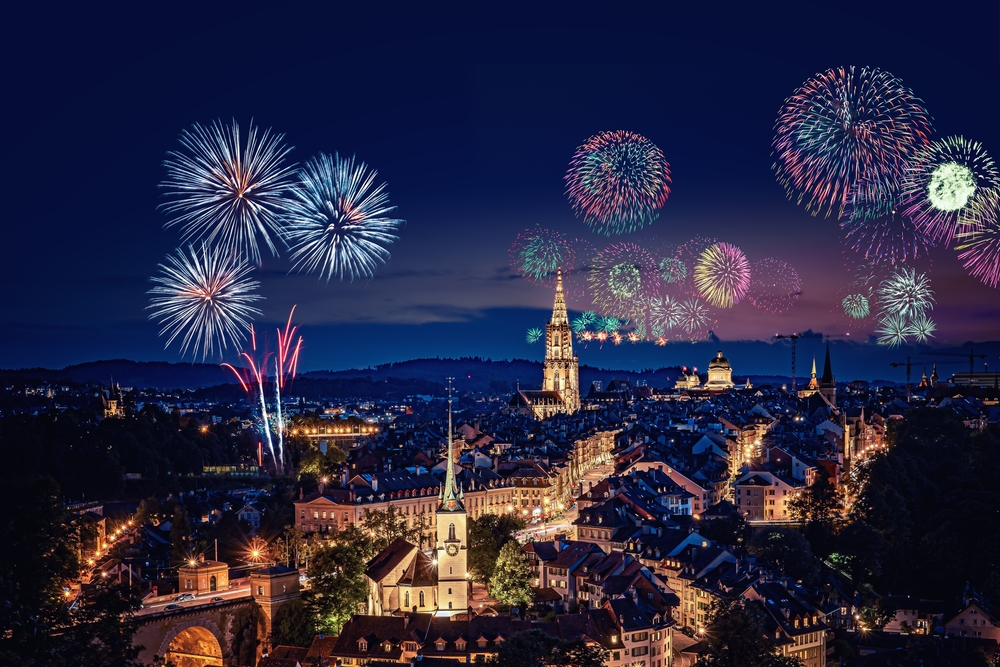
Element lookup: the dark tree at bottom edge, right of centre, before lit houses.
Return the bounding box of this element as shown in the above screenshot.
[698,598,802,667]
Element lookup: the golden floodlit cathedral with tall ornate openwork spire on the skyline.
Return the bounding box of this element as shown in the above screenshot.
[510,269,580,419]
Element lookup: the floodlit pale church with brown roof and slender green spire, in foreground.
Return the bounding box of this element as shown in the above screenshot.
[365,396,469,616]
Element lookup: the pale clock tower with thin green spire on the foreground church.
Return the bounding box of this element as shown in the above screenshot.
[435,378,469,616]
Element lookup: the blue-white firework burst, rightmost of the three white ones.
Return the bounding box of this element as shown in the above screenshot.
[285,153,403,283]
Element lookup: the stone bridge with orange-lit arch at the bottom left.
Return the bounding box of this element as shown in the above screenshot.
[134,595,258,667]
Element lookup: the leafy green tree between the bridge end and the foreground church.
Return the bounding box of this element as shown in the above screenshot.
[302,544,368,635]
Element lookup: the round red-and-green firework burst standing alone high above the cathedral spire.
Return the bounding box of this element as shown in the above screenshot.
[565,131,670,236]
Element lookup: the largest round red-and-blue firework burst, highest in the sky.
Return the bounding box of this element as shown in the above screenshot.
[773,66,931,217]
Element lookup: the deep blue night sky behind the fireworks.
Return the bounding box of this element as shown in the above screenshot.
[0,2,1000,379]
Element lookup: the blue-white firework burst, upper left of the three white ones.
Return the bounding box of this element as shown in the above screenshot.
[160,120,295,264]
